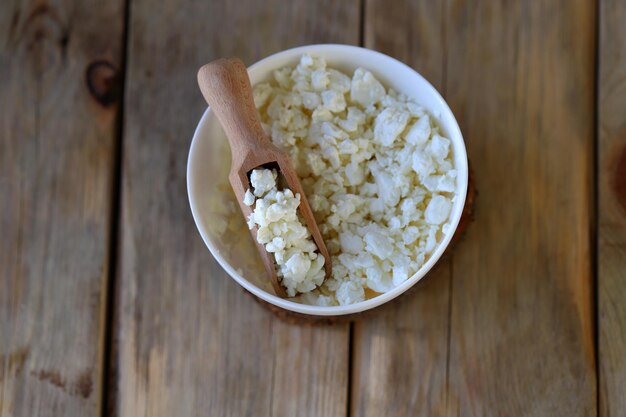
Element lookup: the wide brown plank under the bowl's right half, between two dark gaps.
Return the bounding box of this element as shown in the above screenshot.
[352,0,596,416]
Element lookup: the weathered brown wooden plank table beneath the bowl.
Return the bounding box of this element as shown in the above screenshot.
[0,0,626,417]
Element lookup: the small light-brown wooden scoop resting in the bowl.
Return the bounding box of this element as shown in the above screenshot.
[198,58,332,298]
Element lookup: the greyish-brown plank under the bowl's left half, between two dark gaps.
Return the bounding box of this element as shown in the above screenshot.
[115,0,360,416]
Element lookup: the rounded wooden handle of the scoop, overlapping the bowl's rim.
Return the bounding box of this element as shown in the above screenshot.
[198,58,269,150]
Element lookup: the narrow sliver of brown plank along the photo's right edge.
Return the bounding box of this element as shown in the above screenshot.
[597,0,626,417]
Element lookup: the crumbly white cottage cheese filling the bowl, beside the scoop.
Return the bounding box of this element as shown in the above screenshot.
[246,55,456,305]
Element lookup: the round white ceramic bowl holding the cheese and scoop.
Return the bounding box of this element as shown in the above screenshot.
[187,45,468,316]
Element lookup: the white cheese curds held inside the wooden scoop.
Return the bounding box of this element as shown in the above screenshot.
[243,169,325,297]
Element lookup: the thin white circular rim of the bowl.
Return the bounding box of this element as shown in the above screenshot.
[186,44,469,316]
